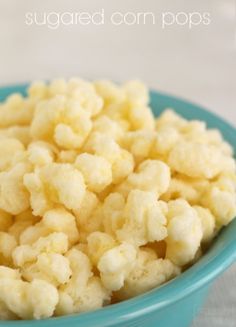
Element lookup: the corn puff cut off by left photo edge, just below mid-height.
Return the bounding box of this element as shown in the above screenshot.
[0,163,31,215]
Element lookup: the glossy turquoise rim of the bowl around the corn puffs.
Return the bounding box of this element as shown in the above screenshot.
[0,83,236,327]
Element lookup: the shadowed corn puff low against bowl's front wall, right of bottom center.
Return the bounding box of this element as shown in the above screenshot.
[116,249,180,300]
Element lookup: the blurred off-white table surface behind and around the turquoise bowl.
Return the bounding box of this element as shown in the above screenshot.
[0,0,236,327]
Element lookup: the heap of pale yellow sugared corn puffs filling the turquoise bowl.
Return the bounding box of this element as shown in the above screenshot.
[0,79,236,319]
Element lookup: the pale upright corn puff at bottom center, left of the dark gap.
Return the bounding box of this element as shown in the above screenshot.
[97,242,136,291]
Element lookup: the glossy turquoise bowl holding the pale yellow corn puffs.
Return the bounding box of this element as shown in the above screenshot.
[0,85,236,327]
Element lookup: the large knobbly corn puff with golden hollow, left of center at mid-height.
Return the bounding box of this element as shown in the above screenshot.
[24,163,86,215]
